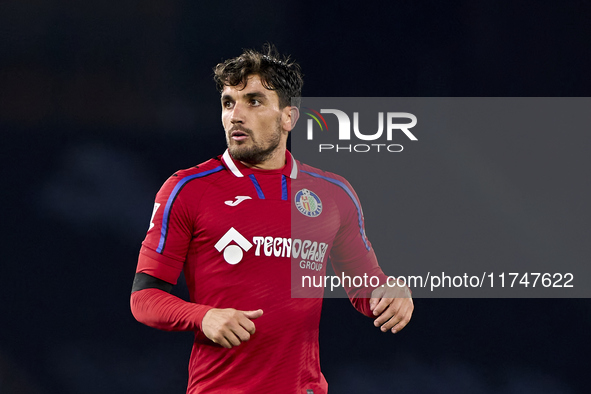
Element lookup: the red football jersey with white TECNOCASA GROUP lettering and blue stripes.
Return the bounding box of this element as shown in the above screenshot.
[137,151,385,394]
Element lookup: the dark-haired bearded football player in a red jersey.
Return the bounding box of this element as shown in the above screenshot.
[131,48,413,394]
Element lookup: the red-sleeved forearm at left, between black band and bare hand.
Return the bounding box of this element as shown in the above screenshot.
[130,288,212,331]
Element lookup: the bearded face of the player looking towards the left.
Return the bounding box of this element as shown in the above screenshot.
[221,75,291,165]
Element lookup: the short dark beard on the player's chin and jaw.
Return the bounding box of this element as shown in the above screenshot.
[226,118,282,165]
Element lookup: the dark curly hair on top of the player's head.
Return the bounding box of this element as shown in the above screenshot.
[213,44,304,108]
